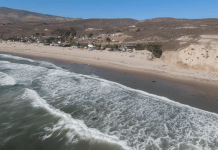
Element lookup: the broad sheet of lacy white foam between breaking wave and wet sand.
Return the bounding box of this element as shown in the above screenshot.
[38,70,218,150]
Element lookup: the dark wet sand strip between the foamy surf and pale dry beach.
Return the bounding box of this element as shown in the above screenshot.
[1,51,218,113]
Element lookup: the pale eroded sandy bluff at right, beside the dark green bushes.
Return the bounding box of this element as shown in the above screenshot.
[162,35,218,72]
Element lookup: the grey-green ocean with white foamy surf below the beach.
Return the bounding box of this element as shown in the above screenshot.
[0,54,218,150]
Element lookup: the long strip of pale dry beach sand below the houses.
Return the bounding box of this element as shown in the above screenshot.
[0,42,218,97]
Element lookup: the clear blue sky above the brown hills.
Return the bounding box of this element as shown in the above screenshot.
[0,0,218,20]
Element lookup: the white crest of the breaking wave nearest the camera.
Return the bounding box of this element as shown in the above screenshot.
[23,89,129,149]
